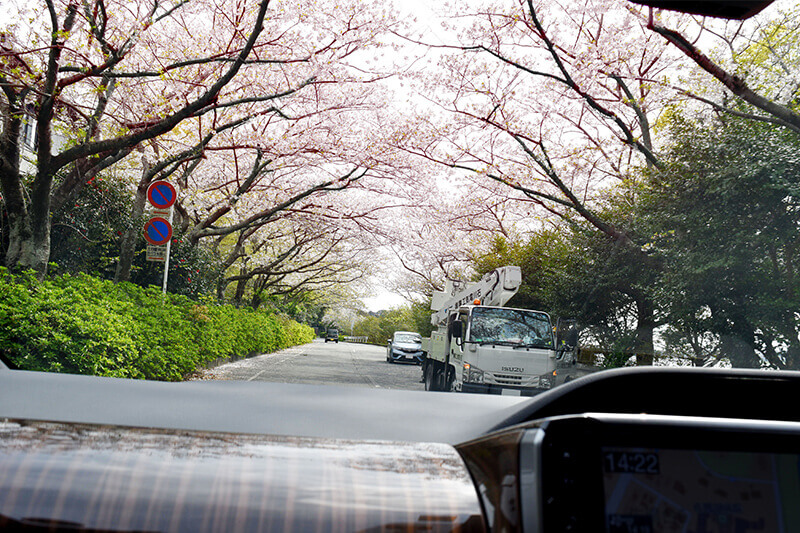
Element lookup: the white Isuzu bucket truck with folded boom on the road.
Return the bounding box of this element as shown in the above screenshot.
[422,266,572,396]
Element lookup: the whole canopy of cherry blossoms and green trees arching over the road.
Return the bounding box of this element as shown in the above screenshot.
[0,0,800,366]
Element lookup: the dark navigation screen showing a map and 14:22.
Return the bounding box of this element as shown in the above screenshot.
[602,448,800,533]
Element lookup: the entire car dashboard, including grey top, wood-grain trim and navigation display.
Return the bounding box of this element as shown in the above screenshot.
[0,368,800,533]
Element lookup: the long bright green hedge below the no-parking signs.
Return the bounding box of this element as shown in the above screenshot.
[0,267,314,381]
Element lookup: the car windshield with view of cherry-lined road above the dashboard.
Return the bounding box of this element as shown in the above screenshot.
[0,0,800,392]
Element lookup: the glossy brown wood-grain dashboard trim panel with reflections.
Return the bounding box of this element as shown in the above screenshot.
[0,422,483,532]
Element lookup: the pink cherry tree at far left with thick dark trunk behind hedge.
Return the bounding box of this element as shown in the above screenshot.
[0,0,400,278]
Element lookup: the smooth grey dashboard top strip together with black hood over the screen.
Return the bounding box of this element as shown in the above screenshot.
[6,367,800,444]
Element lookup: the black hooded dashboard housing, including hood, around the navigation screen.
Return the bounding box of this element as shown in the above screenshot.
[457,368,800,533]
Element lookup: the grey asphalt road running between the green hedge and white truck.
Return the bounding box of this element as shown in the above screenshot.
[194,339,424,390]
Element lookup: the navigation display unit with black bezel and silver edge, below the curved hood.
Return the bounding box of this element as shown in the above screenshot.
[478,413,800,533]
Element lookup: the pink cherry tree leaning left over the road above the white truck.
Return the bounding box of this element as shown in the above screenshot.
[388,0,692,362]
